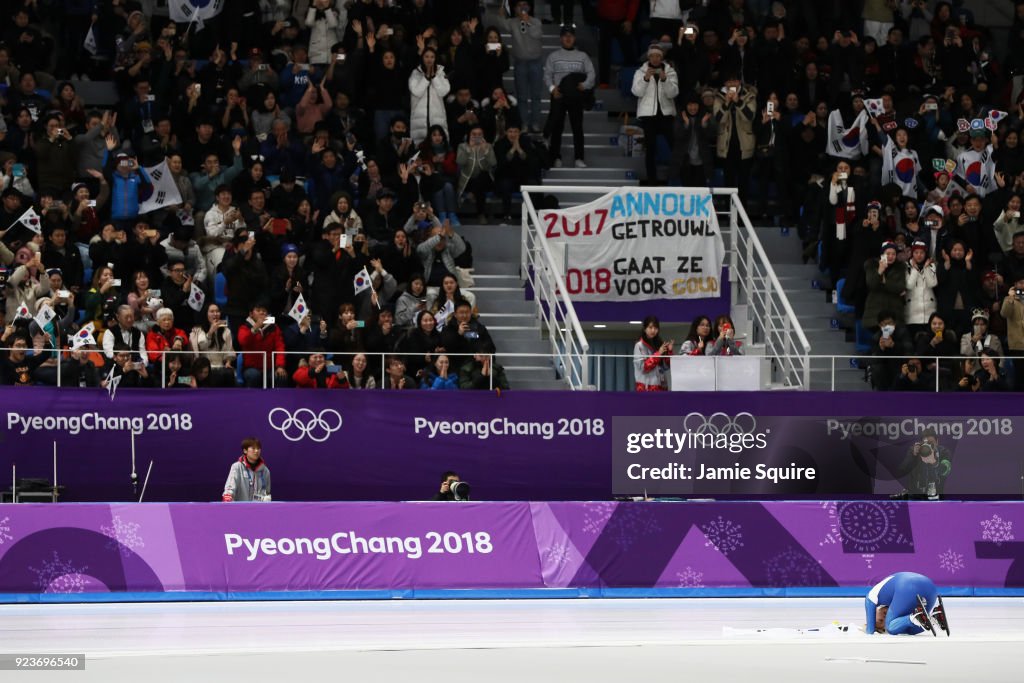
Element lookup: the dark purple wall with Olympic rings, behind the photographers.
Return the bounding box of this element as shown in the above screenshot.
[0,387,1024,503]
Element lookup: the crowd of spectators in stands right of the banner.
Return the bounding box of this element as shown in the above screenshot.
[610,0,1024,391]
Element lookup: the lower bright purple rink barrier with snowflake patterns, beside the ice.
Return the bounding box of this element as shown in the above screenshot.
[0,501,1024,601]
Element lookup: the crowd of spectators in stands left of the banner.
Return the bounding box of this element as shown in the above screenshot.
[0,0,552,390]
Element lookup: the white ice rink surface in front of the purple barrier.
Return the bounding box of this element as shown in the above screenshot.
[0,598,1024,683]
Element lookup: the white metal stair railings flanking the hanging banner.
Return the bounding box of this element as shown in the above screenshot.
[520,185,811,389]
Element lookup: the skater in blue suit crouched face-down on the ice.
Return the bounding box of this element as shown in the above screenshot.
[864,571,949,636]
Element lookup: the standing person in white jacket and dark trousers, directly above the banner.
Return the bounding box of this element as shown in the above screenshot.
[633,43,679,184]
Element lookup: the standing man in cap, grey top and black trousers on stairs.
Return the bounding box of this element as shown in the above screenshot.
[544,26,597,168]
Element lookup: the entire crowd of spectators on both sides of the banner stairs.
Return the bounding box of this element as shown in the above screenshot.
[0,0,1024,391]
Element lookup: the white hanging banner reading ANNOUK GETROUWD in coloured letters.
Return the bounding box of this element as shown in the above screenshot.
[539,187,725,301]
